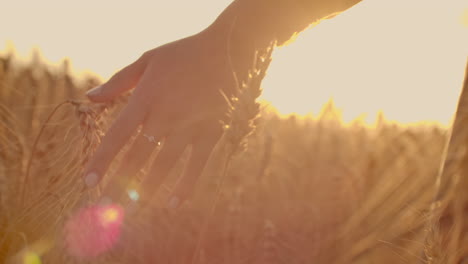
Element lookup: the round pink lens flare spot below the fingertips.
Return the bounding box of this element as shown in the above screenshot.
[65,204,124,258]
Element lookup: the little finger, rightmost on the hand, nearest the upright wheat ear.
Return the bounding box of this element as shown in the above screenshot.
[168,129,222,209]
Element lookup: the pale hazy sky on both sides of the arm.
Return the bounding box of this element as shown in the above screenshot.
[0,0,468,123]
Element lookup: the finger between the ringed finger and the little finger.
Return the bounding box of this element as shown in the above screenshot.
[140,133,190,202]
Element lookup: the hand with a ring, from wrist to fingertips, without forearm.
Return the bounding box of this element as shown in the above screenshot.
[85,26,236,208]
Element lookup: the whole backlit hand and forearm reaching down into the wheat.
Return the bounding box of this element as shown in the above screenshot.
[81,0,361,208]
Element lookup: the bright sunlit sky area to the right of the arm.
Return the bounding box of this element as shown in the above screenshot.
[262,0,468,125]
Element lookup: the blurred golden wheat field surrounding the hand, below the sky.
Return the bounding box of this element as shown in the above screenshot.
[0,51,468,264]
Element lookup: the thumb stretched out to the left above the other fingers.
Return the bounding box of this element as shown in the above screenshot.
[86,52,151,102]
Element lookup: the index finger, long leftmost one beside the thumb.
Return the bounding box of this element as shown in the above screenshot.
[85,67,158,187]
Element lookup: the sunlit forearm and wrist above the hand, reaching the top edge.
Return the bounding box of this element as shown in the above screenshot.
[202,0,361,86]
